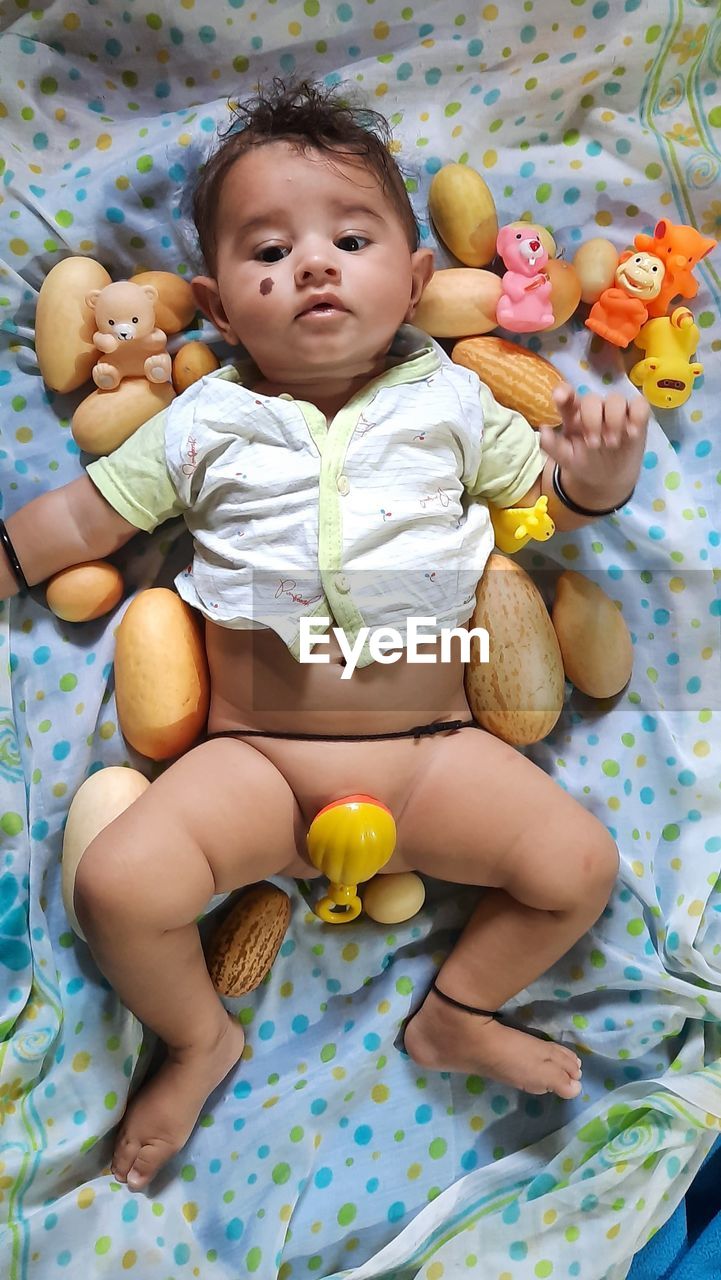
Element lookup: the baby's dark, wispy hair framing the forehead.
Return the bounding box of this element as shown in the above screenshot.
[192,77,420,274]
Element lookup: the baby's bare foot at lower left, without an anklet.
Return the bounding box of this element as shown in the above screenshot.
[110,1018,245,1192]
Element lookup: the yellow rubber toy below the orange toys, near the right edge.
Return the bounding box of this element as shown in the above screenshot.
[629,307,703,408]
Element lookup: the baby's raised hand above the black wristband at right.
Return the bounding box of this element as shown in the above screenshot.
[539,384,649,511]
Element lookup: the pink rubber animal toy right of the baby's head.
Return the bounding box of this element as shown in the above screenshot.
[496,227,553,333]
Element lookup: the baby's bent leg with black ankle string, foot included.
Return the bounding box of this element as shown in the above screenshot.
[398,730,619,1098]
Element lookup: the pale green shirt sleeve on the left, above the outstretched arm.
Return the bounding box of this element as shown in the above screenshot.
[86,408,186,534]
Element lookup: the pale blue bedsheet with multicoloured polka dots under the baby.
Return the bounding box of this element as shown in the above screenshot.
[0,0,721,1280]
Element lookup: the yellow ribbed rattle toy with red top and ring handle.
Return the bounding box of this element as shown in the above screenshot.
[307,795,396,924]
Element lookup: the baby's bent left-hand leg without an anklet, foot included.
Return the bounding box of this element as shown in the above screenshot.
[74,739,305,1190]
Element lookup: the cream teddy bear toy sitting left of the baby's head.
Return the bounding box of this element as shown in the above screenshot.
[85,280,172,392]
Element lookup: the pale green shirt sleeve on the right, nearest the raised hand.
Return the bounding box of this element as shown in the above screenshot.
[467,383,547,507]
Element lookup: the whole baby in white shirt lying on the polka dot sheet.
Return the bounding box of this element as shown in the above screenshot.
[0,81,648,1189]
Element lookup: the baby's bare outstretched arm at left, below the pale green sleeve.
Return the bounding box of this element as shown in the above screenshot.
[0,475,138,600]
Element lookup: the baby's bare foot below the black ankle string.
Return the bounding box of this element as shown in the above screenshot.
[403,991,581,1098]
